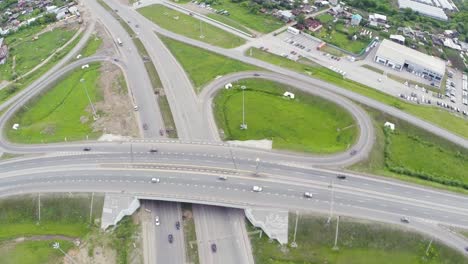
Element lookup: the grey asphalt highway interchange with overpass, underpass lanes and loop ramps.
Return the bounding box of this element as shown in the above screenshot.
[0,0,468,263]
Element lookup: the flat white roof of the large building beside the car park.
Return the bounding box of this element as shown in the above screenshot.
[376,39,445,75]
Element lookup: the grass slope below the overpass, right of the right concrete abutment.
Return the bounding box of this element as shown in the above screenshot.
[251,214,467,264]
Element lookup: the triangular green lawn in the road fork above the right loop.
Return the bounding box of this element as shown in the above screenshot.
[159,36,258,93]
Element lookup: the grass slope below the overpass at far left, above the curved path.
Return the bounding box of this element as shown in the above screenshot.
[0,194,104,241]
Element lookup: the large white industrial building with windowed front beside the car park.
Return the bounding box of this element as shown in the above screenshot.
[374,39,445,84]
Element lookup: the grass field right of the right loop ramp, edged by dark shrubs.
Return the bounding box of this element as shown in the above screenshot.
[351,108,468,190]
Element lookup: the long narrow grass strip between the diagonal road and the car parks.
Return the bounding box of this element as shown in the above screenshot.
[246,48,468,138]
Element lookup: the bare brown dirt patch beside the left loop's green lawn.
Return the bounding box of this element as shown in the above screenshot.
[93,63,138,137]
